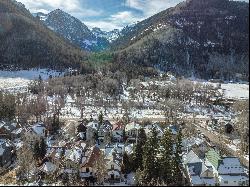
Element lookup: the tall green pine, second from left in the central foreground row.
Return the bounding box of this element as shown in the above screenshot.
[141,128,159,185]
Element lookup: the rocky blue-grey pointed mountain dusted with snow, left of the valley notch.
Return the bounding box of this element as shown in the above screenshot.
[38,9,109,51]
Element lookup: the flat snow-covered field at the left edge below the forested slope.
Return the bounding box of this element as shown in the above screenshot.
[0,69,62,92]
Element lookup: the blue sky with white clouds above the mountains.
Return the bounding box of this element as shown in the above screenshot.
[17,0,249,31]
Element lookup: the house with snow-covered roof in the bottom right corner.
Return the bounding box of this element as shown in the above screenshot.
[218,157,249,186]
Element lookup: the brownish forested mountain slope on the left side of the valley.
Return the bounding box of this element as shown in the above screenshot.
[0,0,86,69]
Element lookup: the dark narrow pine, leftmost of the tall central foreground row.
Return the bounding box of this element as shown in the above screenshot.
[132,128,147,171]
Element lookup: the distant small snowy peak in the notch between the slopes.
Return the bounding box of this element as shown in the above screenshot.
[92,27,120,43]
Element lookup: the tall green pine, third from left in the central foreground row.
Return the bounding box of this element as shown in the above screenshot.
[160,129,173,184]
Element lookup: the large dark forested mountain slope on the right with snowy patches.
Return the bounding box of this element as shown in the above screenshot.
[112,0,249,79]
